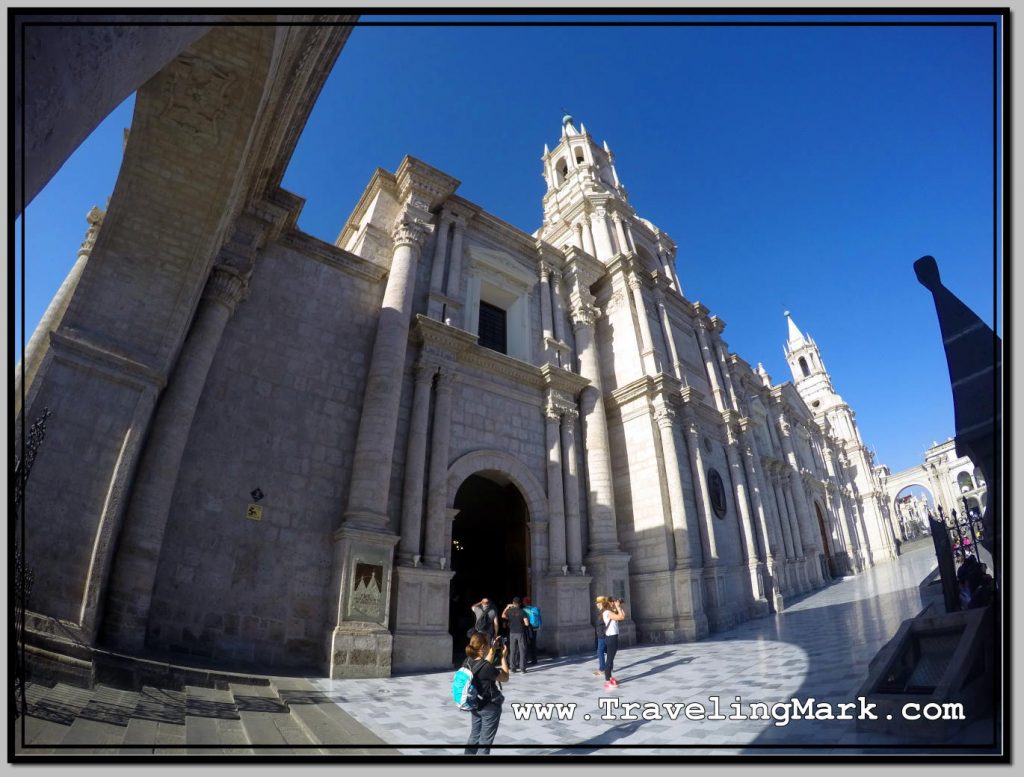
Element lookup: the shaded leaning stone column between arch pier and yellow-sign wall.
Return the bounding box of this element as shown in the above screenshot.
[106,264,248,651]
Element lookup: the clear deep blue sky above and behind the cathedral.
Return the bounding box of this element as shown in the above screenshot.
[15,17,1001,471]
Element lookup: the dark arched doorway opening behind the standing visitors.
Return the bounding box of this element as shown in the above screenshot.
[449,472,530,662]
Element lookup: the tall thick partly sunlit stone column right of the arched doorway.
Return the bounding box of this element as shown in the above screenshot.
[572,304,618,554]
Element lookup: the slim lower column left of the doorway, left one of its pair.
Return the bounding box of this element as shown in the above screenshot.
[398,359,437,566]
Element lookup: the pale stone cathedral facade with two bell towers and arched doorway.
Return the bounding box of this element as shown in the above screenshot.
[19,98,894,677]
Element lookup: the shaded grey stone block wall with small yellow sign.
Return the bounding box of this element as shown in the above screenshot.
[148,238,383,666]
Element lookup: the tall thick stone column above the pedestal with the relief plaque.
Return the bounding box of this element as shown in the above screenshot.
[343,212,429,531]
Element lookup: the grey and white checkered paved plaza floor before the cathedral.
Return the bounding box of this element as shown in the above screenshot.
[313,543,992,756]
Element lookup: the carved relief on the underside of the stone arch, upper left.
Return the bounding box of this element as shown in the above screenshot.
[160,55,239,144]
